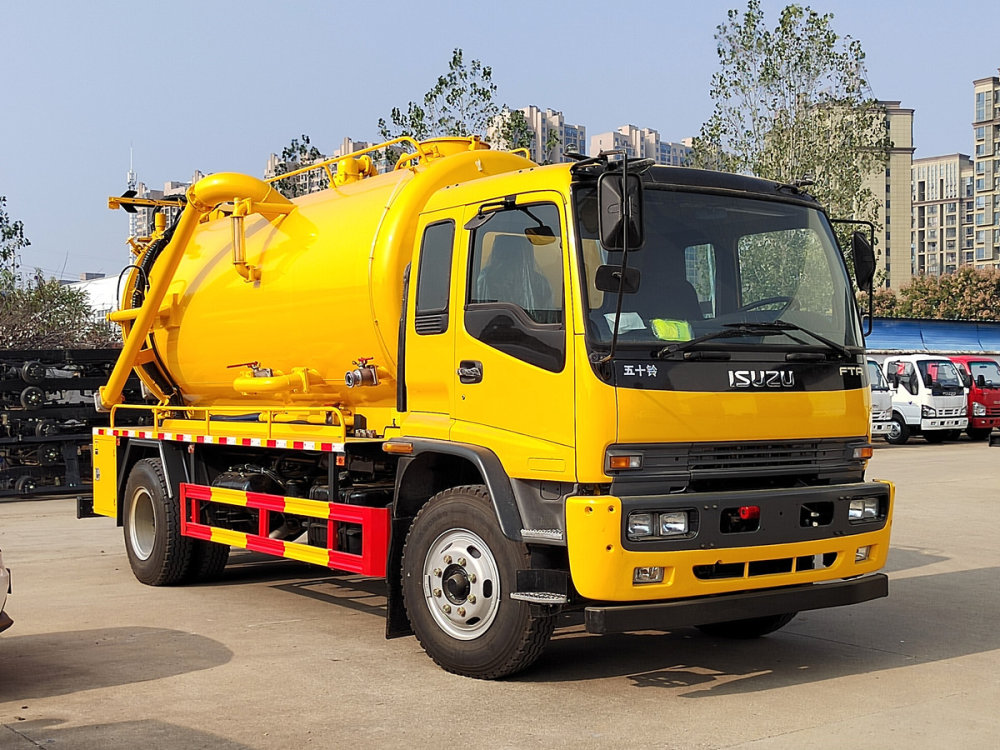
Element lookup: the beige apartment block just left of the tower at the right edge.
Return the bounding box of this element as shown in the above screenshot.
[910,154,974,276]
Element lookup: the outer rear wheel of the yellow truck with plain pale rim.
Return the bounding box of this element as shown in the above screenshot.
[123,458,192,586]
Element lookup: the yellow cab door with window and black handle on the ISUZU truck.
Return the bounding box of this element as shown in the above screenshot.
[451,192,576,479]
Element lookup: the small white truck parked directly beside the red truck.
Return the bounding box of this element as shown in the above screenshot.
[882,354,969,445]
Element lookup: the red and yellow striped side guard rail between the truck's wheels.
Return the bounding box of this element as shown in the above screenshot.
[180,484,390,578]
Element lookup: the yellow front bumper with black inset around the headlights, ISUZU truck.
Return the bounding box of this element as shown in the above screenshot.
[565,482,894,604]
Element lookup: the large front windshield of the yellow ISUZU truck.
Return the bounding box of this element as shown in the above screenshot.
[576,184,860,349]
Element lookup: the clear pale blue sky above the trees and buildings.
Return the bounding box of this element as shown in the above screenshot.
[0,0,1000,278]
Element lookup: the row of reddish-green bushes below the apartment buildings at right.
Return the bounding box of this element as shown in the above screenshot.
[858,266,1000,321]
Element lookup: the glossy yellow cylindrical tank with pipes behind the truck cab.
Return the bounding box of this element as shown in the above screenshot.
[101,139,533,408]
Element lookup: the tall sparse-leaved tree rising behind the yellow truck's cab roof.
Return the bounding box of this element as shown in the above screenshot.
[692,0,892,268]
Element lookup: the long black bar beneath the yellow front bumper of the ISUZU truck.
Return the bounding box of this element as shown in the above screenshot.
[584,573,889,634]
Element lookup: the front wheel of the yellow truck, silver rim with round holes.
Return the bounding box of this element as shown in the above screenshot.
[402,485,555,680]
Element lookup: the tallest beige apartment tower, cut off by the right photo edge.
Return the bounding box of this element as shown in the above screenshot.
[972,71,1000,268]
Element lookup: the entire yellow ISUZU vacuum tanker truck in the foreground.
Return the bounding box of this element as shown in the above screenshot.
[90,138,893,678]
